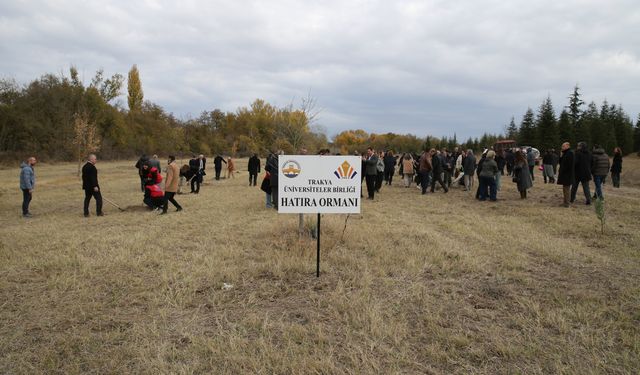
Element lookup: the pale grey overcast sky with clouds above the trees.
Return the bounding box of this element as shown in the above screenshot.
[0,0,640,139]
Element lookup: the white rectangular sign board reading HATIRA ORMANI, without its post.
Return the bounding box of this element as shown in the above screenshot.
[278,155,362,214]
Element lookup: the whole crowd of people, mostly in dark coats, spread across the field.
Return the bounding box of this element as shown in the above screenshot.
[20,142,622,218]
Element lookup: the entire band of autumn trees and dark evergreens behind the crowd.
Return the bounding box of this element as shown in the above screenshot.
[0,65,640,162]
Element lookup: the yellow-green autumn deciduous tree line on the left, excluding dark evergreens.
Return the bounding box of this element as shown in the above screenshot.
[0,65,328,160]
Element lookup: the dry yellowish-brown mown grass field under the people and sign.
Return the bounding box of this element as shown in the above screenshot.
[0,158,640,374]
